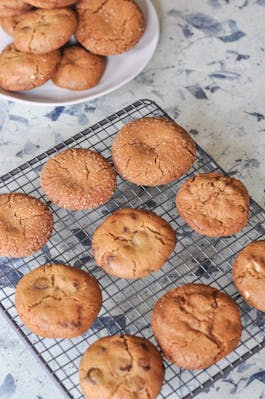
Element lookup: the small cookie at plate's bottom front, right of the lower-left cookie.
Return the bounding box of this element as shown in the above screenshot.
[52,46,106,90]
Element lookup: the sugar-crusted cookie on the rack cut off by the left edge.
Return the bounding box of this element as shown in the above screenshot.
[0,193,53,258]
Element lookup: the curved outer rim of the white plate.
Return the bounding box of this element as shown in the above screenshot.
[0,0,160,107]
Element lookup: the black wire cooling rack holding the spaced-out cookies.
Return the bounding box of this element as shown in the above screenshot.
[0,100,265,399]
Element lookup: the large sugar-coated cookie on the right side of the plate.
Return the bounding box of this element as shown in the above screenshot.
[75,0,145,55]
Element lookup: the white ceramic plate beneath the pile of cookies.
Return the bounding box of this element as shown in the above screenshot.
[0,0,159,106]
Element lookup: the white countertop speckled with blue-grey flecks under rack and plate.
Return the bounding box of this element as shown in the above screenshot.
[0,0,265,399]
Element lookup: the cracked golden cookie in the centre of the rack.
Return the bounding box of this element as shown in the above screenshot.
[92,208,176,278]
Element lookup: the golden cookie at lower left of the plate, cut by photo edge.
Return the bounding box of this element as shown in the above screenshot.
[0,44,61,91]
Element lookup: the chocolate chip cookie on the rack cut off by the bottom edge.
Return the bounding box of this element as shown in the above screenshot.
[79,335,164,399]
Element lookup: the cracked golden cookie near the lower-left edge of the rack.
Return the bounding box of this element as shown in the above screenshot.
[15,264,102,338]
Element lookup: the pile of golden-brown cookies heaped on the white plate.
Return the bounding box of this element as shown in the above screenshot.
[0,0,145,91]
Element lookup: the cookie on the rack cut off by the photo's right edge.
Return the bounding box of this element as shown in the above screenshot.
[233,240,265,312]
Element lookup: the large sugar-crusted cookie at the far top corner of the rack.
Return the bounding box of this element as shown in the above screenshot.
[112,117,196,186]
